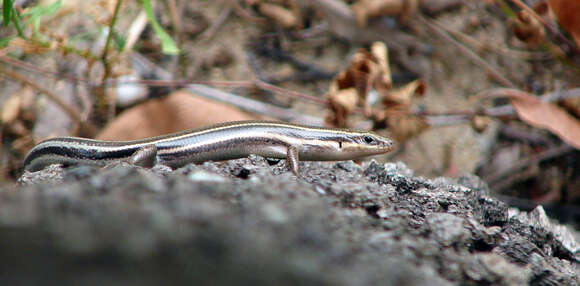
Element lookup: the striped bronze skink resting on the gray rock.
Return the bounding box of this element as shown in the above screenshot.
[24,121,393,175]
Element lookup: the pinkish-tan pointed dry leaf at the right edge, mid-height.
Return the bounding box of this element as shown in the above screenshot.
[506,90,580,149]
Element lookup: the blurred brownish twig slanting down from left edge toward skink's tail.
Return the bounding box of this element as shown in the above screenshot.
[0,66,97,134]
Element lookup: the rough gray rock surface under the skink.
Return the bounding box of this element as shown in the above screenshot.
[0,156,580,285]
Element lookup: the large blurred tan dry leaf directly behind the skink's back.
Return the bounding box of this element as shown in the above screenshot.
[97,91,257,140]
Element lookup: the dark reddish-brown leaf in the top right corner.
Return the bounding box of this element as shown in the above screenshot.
[550,0,580,47]
